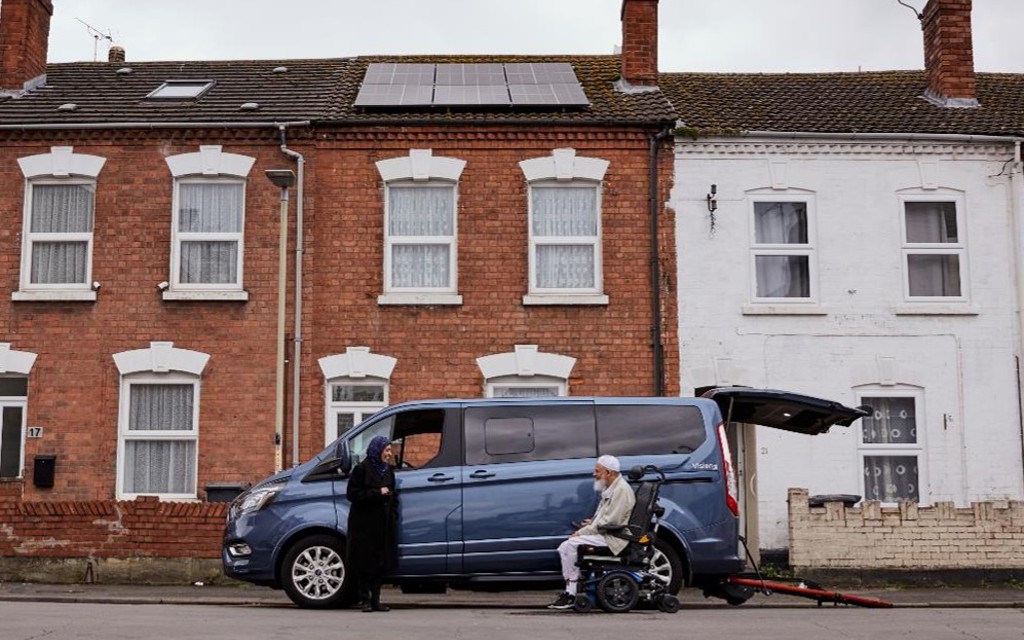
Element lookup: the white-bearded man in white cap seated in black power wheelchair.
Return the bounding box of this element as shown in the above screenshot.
[551,456,679,613]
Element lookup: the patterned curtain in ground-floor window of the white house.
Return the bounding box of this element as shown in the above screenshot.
[860,397,921,502]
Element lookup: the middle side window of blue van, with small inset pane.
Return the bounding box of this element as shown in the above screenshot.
[465,404,597,465]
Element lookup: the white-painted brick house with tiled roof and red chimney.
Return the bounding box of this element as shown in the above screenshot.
[659,0,1024,550]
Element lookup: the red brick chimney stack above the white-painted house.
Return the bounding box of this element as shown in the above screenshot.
[921,0,978,106]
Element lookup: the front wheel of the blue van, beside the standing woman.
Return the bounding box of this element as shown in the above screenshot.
[281,535,355,609]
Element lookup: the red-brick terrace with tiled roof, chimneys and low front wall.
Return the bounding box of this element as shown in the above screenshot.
[0,0,679,578]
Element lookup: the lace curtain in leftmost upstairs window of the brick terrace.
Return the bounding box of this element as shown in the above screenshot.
[30,184,96,285]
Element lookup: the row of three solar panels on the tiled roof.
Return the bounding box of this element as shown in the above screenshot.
[354,62,590,106]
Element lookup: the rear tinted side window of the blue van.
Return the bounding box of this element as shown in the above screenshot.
[597,404,707,456]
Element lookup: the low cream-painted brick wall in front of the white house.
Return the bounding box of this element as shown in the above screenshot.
[790,488,1024,569]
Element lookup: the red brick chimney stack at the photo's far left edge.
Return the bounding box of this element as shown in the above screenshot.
[0,0,53,93]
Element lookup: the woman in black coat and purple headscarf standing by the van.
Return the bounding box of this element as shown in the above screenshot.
[346,435,398,611]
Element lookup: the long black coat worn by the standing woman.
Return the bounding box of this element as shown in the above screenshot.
[345,460,398,573]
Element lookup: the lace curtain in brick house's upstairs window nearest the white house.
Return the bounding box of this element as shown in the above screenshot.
[530,186,598,289]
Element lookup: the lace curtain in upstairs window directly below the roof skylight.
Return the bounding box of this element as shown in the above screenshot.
[178,183,245,285]
